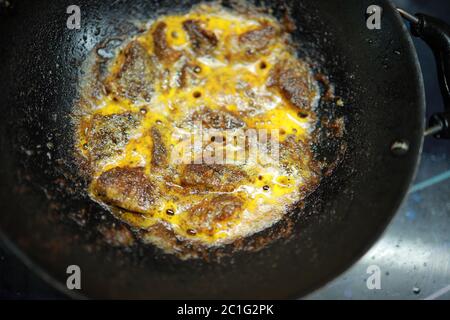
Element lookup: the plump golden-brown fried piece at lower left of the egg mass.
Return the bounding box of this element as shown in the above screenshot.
[93,167,158,214]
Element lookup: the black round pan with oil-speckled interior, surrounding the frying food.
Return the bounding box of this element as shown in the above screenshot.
[0,0,445,298]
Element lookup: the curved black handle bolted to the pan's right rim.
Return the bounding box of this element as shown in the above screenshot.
[397,8,450,139]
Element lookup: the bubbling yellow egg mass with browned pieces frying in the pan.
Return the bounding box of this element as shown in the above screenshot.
[76,4,334,254]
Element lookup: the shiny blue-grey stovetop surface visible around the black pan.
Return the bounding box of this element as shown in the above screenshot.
[0,0,450,299]
